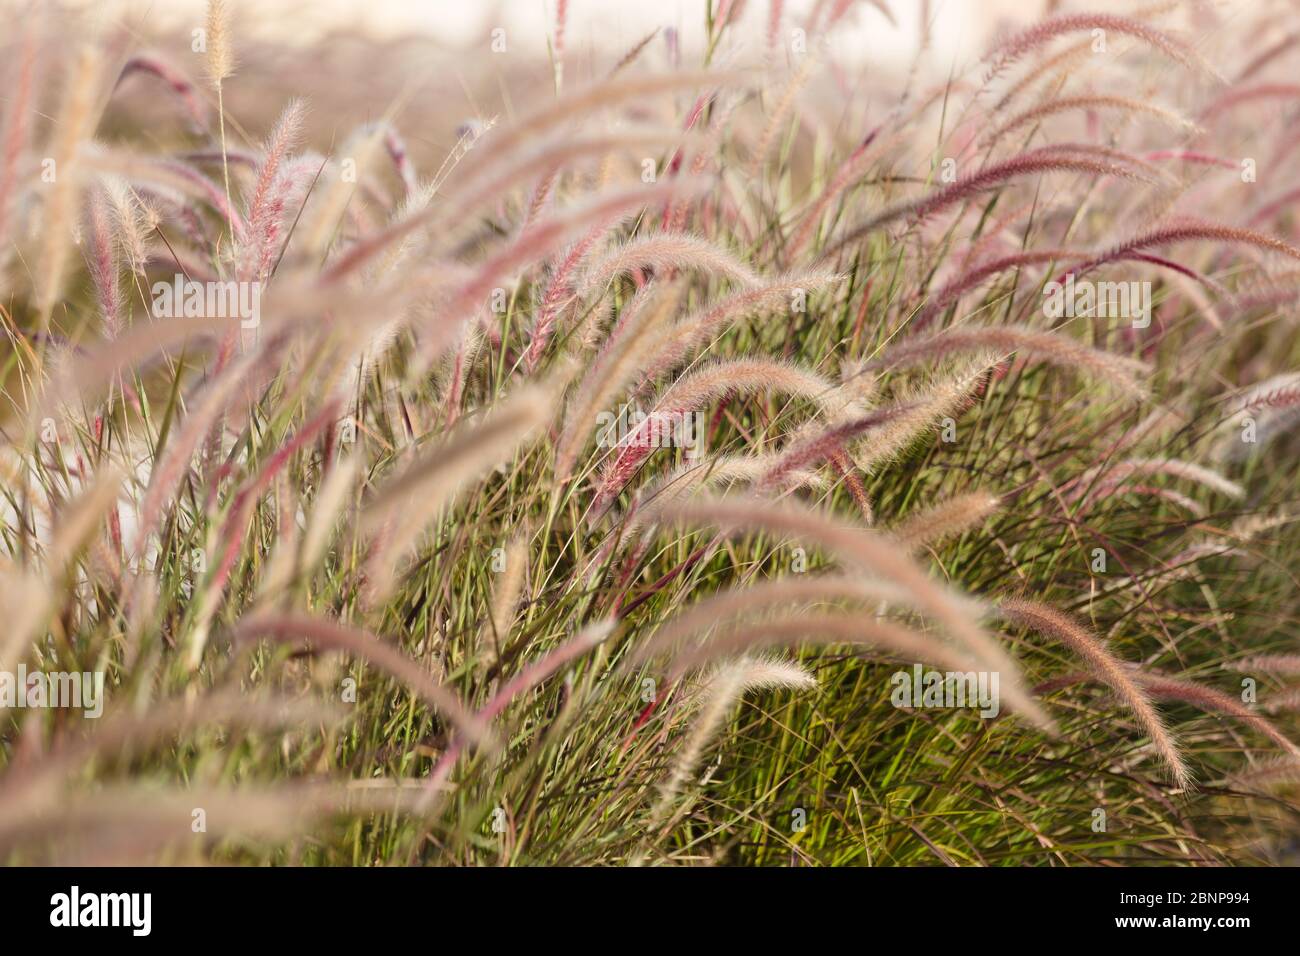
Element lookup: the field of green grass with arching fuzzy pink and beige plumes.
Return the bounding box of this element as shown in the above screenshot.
[0,0,1300,866]
